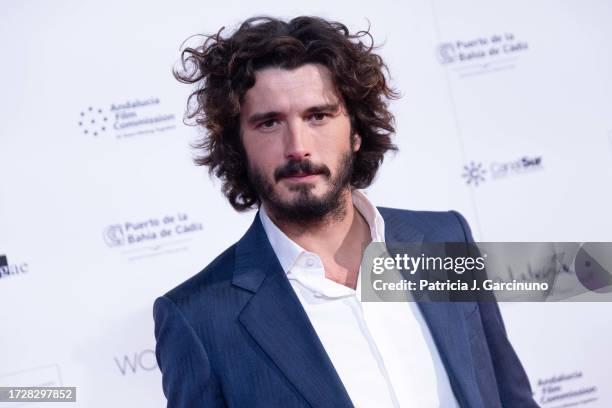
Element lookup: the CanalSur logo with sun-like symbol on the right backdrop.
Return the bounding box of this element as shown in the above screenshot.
[461,155,544,187]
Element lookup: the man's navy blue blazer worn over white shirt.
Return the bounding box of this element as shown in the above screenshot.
[153,208,537,408]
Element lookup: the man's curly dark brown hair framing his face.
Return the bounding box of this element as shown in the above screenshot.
[173,16,398,211]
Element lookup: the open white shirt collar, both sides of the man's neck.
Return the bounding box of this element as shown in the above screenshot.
[259,190,385,273]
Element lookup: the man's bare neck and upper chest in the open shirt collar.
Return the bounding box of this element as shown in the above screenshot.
[268,190,371,289]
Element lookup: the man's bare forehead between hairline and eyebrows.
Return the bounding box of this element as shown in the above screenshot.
[243,64,338,112]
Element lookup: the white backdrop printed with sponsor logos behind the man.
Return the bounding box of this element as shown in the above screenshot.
[0,0,612,407]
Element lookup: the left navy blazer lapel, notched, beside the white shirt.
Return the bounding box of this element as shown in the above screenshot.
[233,214,353,407]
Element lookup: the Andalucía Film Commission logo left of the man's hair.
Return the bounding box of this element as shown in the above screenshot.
[77,97,177,139]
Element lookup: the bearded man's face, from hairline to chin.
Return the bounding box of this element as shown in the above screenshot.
[240,64,361,223]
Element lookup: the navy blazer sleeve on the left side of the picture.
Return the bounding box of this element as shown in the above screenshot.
[153,296,226,408]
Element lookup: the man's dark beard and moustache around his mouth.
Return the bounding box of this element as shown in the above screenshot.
[249,150,355,227]
